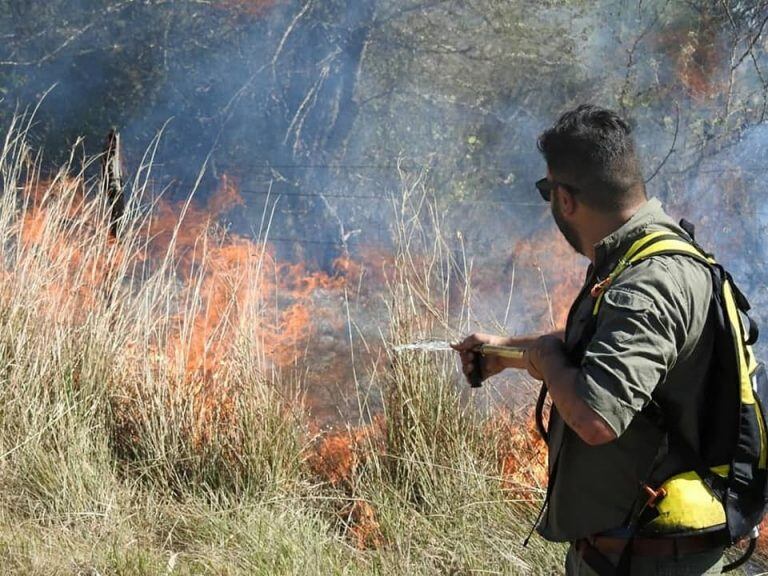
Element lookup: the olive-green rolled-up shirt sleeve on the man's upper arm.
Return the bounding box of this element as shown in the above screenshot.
[577,257,709,436]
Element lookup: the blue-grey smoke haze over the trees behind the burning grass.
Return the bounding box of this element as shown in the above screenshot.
[0,0,768,414]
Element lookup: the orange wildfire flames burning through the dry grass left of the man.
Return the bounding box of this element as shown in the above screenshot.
[7,158,565,549]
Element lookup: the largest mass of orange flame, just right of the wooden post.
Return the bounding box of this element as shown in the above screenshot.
[144,177,346,388]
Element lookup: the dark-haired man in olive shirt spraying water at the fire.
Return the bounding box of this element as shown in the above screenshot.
[456,105,723,575]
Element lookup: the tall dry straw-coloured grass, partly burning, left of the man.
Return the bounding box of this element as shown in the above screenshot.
[0,119,562,574]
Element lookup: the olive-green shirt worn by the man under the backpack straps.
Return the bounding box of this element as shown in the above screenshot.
[538,199,714,541]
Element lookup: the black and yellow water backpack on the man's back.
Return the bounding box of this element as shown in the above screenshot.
[536,221,768,573]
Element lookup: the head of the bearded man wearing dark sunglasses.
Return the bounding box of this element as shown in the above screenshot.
[538,105,647,254]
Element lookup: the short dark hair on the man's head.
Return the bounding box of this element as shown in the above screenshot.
[538,104,646,211]
